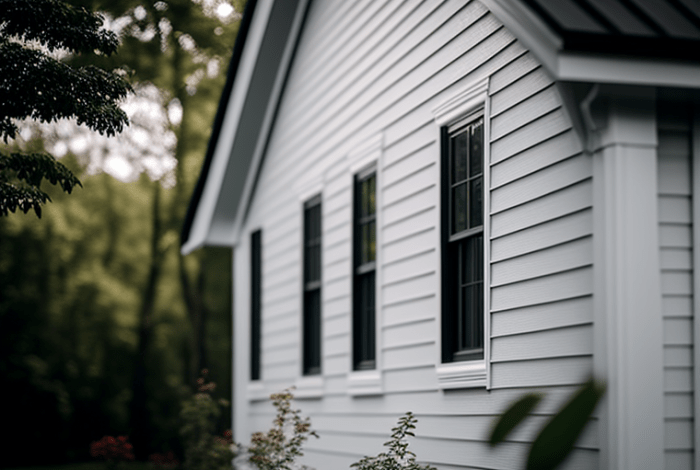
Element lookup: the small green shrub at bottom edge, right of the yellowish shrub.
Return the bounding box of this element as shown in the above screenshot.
[351,411,434,470]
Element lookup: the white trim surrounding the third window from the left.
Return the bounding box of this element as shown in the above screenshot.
[347,133,384,396]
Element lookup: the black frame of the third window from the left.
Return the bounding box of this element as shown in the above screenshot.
[352,162,378,372]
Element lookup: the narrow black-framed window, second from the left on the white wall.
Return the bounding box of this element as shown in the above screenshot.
[302,194,323,376]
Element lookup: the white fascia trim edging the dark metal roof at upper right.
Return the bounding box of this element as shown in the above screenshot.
[481,0,700,88]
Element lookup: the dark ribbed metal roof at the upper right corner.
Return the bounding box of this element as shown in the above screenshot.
[521,0,700,61]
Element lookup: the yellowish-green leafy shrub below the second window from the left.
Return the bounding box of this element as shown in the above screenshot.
[248,389,318,470]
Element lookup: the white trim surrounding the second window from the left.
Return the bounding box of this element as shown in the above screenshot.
[294,185,325,398]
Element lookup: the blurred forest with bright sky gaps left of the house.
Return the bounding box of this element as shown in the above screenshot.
[0,0,245,467]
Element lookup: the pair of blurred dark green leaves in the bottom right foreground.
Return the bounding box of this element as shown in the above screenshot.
[489,378,605,470]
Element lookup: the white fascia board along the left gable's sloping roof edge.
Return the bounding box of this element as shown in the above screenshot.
[180,0,274,255]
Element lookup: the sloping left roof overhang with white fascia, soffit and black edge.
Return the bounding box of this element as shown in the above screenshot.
[181,0,308,254]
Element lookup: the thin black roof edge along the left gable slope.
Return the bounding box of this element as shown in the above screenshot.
[180,0,257,250]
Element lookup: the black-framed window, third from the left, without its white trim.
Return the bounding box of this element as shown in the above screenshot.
[353,167,377,370]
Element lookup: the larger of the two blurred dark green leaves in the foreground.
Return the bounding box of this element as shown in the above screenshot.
[526,378,605,470]
